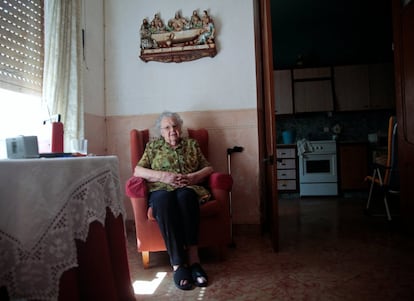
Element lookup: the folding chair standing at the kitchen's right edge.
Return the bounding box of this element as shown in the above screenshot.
[365,116,399,221]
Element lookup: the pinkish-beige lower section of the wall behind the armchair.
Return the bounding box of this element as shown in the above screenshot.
[85,109,260,224]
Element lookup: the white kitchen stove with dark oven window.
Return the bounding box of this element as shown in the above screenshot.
[298,140,338,196]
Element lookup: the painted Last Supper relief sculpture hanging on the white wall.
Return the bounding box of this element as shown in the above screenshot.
[140,10,217,63]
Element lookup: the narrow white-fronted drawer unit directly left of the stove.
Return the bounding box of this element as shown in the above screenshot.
[276,145,298,191]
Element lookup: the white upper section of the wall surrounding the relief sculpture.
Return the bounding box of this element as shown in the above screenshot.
[103,0,257,116]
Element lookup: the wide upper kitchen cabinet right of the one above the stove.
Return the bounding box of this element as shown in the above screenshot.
[334,64,395,111]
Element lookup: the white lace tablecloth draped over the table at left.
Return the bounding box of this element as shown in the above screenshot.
[0,156,125,300]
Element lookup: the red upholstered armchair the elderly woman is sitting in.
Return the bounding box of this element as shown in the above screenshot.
[126,129,233,268]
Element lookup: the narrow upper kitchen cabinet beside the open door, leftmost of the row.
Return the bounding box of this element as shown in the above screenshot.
[273,69,293,115]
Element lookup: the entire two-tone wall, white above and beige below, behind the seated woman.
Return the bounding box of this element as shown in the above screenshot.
[83,0,260,224]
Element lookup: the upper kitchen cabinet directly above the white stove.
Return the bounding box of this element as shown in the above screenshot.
[293,67,334,113]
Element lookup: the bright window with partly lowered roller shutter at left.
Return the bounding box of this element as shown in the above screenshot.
[0,0,47,158]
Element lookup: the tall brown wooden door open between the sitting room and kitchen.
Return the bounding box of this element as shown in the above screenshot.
[254,0,279,251]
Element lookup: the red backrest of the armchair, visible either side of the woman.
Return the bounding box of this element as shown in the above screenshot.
[130,128,208,172]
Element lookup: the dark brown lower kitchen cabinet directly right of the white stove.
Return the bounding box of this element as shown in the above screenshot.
[339,142,369,191]
